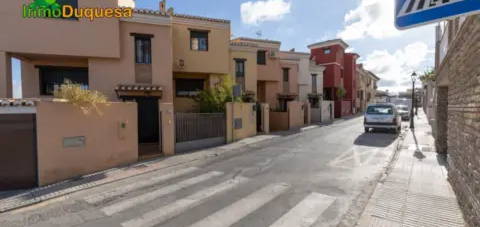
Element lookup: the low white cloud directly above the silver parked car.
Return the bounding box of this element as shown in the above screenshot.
[363,42,433,92]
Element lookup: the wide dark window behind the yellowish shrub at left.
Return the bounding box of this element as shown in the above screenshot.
[39,67,88,95]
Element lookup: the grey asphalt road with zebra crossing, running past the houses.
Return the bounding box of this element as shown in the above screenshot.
[0,117,397,227]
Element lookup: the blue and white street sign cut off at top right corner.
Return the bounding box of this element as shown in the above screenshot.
[395,0,480,29]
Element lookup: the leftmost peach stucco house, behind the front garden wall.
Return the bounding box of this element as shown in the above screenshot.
[0,0,178,160]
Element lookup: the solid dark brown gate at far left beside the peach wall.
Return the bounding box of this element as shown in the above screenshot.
[0,114,38,190]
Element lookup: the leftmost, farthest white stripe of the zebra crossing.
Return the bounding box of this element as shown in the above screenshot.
[84,167,198,204]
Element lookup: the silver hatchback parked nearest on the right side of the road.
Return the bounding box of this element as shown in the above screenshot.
[364,103,402,133]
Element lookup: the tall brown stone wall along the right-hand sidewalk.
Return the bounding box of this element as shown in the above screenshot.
[437,15,480,226]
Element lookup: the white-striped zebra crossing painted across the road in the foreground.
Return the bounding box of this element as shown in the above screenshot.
[84,168,335,227]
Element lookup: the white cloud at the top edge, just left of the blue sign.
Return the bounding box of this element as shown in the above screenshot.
[337,0,400,40]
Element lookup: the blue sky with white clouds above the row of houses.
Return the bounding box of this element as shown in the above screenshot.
[13,0,435,97]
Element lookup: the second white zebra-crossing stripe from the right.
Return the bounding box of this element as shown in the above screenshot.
[191,184,290,227]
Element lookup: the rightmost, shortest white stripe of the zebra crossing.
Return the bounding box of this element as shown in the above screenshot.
[270,193,335,227]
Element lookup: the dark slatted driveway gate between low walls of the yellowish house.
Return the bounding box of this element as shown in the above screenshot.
[175,113,227,152]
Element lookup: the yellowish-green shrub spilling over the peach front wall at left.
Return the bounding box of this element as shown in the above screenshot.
[54,81,107,115]
